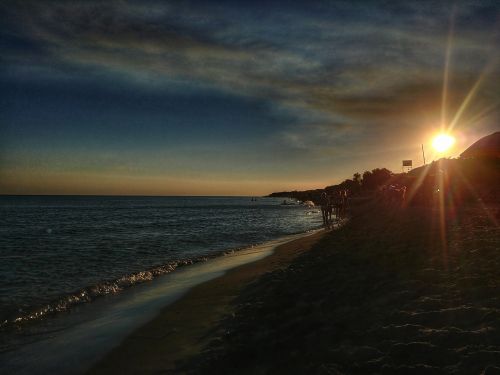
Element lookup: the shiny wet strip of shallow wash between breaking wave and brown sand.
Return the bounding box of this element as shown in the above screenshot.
[0,230,318,374]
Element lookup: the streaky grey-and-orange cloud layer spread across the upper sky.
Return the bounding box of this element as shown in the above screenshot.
[3,1,500,181]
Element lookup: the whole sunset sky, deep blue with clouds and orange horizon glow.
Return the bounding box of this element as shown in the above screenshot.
[0,0,500,195]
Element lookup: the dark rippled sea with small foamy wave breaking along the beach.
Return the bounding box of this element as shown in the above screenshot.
[0,196,321,373]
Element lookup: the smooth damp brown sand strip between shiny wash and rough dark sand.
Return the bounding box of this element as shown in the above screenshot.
[87,230,327,374]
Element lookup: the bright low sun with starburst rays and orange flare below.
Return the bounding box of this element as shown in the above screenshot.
[408,9,500,254]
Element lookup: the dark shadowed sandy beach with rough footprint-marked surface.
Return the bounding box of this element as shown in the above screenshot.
[91,203,500,375]
